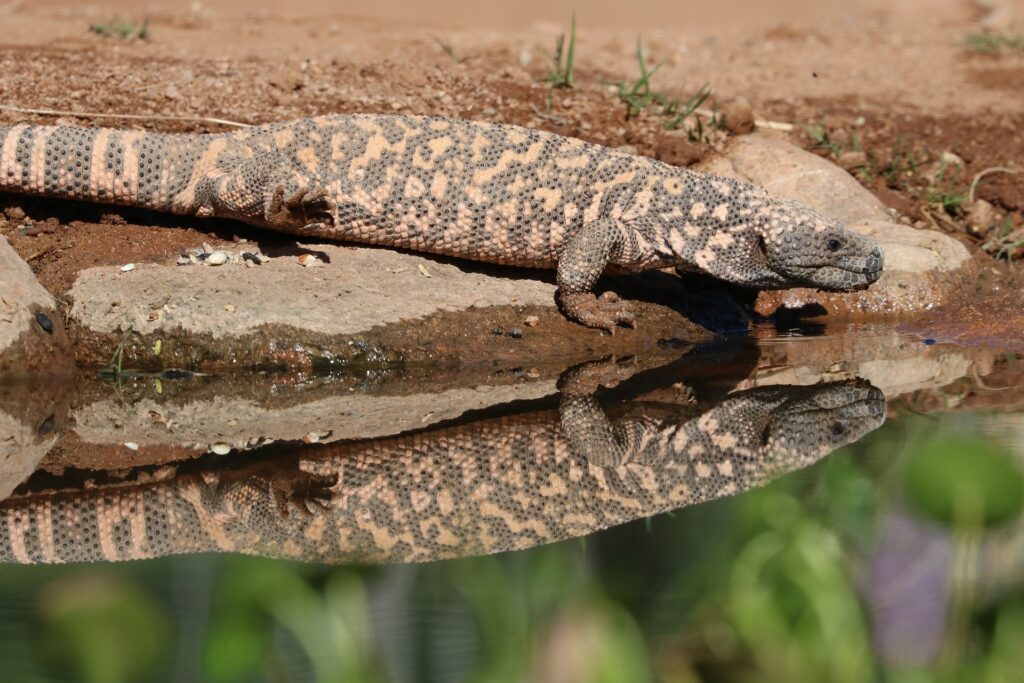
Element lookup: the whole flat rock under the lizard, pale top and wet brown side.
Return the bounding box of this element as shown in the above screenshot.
[67,243,711,368]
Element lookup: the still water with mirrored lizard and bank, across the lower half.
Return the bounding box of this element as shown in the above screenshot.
[0,327,1024,682]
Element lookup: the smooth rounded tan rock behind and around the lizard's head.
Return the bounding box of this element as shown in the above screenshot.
[699,134,973,316]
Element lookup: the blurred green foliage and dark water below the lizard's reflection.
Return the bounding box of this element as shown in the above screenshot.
[0,416,1024,683]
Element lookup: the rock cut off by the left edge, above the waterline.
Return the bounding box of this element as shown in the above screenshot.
[0,237,72,376]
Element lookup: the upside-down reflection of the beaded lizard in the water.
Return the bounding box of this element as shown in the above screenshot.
[0,368,886,563]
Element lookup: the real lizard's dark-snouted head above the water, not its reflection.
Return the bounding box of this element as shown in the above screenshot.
[754,200,883,292]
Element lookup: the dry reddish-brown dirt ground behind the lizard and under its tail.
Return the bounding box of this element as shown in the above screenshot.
[0,0,1024,327]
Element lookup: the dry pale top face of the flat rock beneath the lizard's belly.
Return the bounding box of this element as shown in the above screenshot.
[70,244,555,339]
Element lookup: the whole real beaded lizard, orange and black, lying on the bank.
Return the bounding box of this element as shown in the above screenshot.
[0,114,883,332]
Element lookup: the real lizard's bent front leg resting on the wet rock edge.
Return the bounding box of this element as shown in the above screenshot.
[557,218,640,334]
